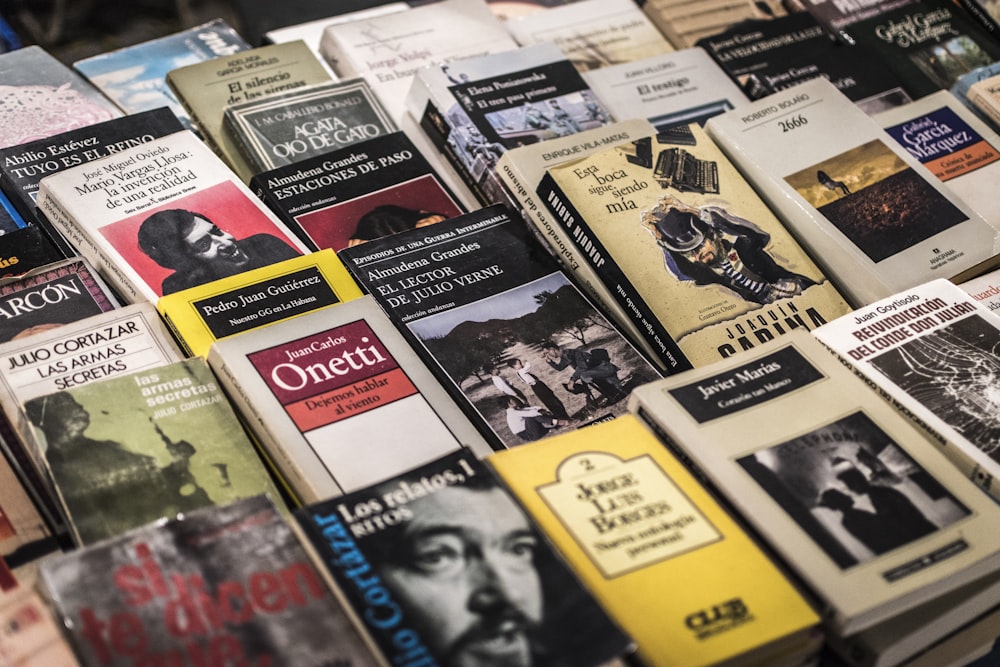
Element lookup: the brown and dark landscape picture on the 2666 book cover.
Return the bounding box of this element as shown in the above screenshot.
[785,139,967,262]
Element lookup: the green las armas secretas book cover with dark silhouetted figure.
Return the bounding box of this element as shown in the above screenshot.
[24,357,280,545]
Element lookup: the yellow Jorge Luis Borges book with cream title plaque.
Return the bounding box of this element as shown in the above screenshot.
[486,415,821,667]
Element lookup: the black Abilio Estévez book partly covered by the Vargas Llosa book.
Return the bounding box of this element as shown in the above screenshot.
[0,107,184,235]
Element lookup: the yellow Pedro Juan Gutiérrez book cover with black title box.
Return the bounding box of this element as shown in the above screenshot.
[156,250,361,356]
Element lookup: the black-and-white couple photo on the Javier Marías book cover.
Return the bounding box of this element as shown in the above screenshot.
[738,412,969,569]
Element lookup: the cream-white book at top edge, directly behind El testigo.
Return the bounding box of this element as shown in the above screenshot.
[505,0,674,72]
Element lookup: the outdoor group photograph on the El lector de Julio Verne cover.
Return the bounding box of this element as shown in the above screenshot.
[407,273,656,445]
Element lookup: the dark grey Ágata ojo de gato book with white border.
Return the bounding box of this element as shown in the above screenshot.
[222,79,396,174]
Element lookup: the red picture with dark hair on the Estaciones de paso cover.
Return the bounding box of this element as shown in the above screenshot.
[295,174,464,252]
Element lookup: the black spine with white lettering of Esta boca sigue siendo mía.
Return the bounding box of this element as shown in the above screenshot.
[537,174,692,374]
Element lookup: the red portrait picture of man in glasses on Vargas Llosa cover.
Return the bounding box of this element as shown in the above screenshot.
[100,183,302,296]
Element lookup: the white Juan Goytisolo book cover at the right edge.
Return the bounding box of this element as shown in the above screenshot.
[813,279,1000,499]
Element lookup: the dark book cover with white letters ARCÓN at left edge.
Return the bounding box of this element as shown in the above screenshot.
[0,257,120,343]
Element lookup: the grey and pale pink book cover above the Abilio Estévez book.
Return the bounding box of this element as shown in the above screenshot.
[0,45,123,148]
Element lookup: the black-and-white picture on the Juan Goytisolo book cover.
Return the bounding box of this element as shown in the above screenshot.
[869,314,1000,462]
